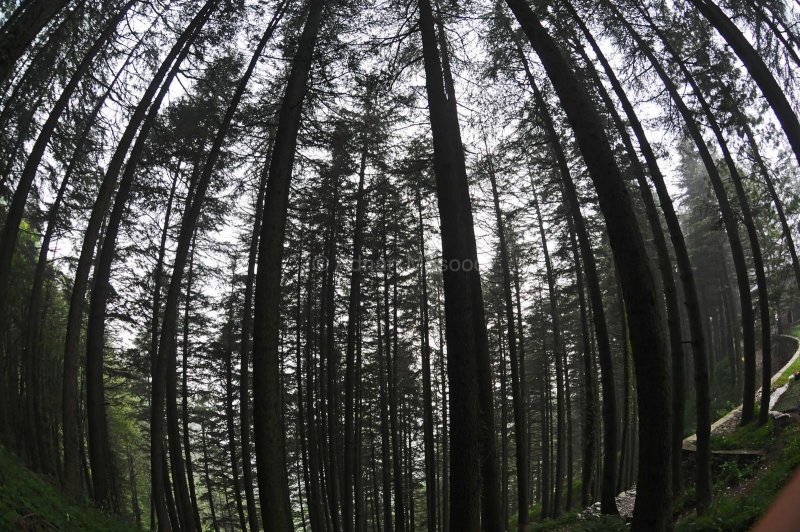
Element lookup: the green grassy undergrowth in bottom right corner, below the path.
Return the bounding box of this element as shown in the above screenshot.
[675,426,800,532]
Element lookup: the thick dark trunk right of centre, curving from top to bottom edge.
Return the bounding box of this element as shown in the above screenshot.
[507,0,672,530]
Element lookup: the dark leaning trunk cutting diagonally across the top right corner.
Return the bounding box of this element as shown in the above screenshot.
[689,0,800,167]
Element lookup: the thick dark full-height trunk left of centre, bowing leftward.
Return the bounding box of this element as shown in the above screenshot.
[253,0,324,532]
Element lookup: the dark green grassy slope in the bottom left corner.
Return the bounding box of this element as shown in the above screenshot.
[0,447,135,532]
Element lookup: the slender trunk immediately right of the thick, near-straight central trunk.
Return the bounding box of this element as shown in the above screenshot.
[484,147,528,531]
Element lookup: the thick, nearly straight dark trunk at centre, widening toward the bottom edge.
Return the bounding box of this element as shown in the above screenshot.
[418,0,503,530]
